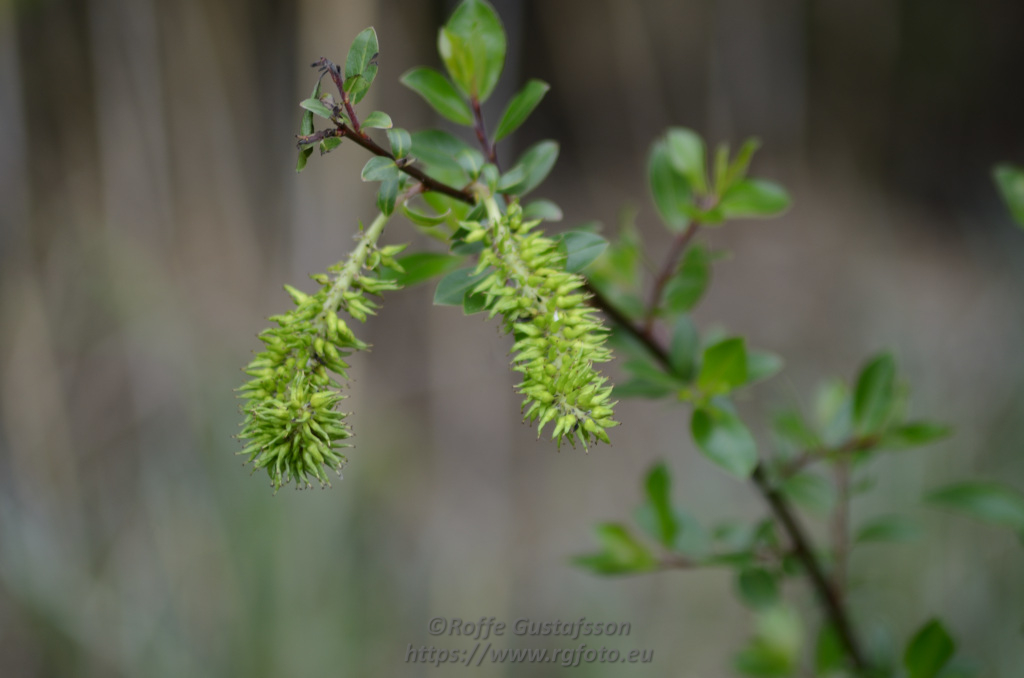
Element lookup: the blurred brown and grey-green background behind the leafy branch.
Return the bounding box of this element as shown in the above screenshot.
[0,0,1024,678]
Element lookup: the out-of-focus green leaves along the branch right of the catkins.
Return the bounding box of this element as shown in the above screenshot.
[574,123,1003,678]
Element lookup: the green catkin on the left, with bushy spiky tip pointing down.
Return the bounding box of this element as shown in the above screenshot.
[238,214,403,492]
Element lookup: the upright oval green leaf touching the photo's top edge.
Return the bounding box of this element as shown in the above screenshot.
[437,0,506,103]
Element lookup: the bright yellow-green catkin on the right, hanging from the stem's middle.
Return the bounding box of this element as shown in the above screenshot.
[461,197,617,448]
